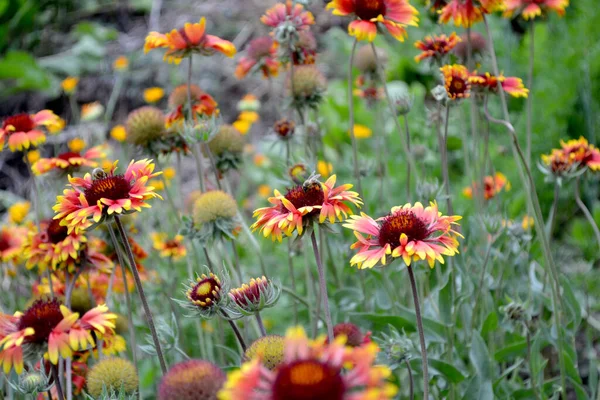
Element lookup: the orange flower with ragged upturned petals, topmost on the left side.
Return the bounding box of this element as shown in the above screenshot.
[144,17,236,64]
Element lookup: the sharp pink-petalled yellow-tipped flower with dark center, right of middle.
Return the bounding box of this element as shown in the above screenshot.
[344,203,462,269]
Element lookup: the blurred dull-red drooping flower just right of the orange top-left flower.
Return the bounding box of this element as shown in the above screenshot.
[235,36,279,79]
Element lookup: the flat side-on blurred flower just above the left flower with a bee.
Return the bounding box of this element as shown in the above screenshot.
[31,145,106,175]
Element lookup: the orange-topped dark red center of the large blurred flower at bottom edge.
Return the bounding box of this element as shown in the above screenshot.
[273,360,346,400]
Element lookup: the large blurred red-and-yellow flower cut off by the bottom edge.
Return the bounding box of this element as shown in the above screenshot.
[219,328,398,400]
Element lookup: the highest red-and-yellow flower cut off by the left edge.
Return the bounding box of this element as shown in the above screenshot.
[0,110,59,152]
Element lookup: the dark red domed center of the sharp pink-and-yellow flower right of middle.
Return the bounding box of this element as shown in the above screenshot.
[379,210,429,249]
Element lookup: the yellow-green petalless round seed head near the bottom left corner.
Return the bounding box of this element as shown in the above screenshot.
[87,357,139,399]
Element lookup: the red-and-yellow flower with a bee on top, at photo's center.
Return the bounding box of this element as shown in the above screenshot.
[251,175,363,241]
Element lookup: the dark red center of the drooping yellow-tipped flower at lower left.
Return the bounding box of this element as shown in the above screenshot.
[18,299,63,344]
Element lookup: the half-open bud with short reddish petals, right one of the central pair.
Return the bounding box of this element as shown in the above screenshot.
[229,276,281,315]
